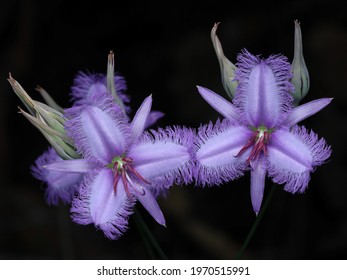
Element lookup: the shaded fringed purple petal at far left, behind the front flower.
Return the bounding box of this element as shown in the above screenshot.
[31,148,83,205]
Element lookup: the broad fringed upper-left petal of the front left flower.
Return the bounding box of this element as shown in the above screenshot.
[65,91,130,164]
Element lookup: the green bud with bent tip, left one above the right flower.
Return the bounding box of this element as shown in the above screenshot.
[211,23,237,99]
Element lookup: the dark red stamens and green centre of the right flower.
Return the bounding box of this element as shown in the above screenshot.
[236,126,273,162]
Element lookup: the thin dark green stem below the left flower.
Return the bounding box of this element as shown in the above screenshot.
[134,207,167,260]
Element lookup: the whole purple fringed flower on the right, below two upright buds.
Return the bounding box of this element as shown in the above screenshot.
[195,51,332,214]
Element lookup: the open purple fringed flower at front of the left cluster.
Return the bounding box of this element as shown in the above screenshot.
[46,89,194,239]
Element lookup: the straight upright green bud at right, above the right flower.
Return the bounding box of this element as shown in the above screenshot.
[291,20,310,105]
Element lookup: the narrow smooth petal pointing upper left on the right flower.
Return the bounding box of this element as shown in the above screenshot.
[197,86,240,122]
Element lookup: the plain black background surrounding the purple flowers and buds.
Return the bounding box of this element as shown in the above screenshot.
[0,0,347,259]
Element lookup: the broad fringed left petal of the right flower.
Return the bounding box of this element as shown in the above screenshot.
[195,119,252,185]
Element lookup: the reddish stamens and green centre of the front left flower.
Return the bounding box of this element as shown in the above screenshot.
[107,156,149,197]
